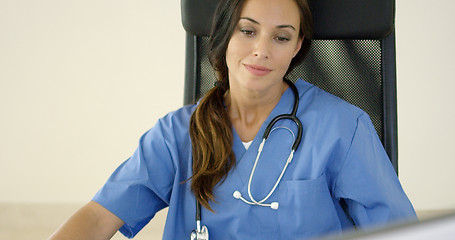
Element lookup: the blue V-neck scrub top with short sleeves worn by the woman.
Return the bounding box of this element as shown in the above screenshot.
[93,80,416,240]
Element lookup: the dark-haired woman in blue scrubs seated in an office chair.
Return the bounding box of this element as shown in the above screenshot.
[51,0,415,240]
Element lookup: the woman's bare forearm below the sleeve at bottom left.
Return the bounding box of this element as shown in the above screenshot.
[49,201,124,240]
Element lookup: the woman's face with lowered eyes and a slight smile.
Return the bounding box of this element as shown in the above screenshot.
[226,0,303,92]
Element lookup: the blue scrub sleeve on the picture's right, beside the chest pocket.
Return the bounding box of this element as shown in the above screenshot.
[334,113,416,228]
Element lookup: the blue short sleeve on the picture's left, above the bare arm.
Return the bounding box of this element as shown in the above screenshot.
[93,123,175,238]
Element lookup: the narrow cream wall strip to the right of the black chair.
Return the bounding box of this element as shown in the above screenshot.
[396,0,455,209]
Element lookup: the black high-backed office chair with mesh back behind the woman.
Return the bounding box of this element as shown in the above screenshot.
[181,0,398,173]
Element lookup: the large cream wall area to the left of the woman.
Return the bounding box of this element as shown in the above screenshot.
[0,0,185,202]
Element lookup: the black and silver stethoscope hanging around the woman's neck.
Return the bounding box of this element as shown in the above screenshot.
[191,79,303,240]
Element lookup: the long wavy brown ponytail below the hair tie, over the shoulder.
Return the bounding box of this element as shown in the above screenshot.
[190,82,235,211]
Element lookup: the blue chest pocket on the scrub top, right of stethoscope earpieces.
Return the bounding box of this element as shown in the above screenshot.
[278,175,341,239]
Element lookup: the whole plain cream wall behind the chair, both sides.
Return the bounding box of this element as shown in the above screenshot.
[0,0,455,210]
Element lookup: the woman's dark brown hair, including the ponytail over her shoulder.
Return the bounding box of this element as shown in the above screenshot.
[190,0,313,210]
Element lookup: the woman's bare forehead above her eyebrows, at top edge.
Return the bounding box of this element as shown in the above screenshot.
[240,0,300,26]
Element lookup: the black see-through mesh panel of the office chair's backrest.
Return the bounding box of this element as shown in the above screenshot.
[196,37,384,140]
